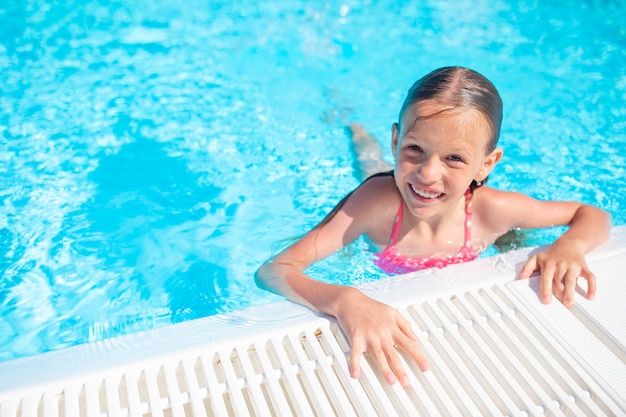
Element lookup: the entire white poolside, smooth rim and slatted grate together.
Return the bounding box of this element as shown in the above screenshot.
[0,227,626,417]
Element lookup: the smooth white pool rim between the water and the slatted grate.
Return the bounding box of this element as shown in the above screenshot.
[0,226,626,413]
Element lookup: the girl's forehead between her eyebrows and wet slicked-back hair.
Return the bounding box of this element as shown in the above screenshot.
[400,100,491,147]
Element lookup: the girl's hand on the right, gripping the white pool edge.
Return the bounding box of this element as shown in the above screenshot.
[519,241,596,307]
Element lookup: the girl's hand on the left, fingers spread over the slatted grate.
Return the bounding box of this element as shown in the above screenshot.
[335,287,428,387]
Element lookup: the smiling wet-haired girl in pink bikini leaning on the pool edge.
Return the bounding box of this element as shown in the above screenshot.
[256,67,610,386]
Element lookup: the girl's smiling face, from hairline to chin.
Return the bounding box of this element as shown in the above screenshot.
[392,100,502,218]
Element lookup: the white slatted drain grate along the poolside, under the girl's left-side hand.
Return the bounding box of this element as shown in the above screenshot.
[0,283,626,417]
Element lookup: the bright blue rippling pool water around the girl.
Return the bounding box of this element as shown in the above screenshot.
[0,0,626,360]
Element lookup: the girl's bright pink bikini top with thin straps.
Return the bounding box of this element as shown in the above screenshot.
[374,189,479,274]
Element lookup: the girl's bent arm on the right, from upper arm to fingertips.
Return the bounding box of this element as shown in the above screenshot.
[478,190,611,307]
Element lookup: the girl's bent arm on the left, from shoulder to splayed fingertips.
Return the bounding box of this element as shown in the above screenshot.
[256,178,427,386]
